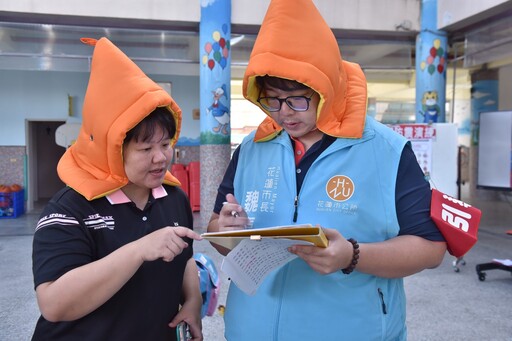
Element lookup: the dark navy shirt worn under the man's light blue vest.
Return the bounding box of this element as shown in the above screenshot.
[213,135,444,241]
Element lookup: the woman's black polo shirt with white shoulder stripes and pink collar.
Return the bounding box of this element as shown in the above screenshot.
[32,186,193,340]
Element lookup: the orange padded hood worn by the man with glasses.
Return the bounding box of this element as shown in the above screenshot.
[243,0,367,141]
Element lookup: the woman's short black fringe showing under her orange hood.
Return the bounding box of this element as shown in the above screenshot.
[124,107,176,143]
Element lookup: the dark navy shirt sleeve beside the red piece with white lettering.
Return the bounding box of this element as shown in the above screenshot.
[396,143,444,241]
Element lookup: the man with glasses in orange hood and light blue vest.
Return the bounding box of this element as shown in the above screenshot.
[208,0,446,341]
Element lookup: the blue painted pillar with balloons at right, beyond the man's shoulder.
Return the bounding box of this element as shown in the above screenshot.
[416,0,447,123]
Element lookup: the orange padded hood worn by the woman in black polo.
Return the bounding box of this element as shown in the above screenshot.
[57,38,181,200]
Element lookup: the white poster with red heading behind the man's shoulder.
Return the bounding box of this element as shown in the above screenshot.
[390,124,436,176]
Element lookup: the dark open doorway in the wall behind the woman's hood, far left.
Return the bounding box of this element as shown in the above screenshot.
[26,120,66,211]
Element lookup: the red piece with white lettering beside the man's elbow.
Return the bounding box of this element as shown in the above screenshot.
[430,189,482,257]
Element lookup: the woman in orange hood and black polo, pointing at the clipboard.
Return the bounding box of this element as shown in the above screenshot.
[33,38,202,340]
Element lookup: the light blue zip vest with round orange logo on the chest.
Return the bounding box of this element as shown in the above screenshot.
[224,118,406,341]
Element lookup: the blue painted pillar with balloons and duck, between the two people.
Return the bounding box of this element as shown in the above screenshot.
[199,0,231,227]
